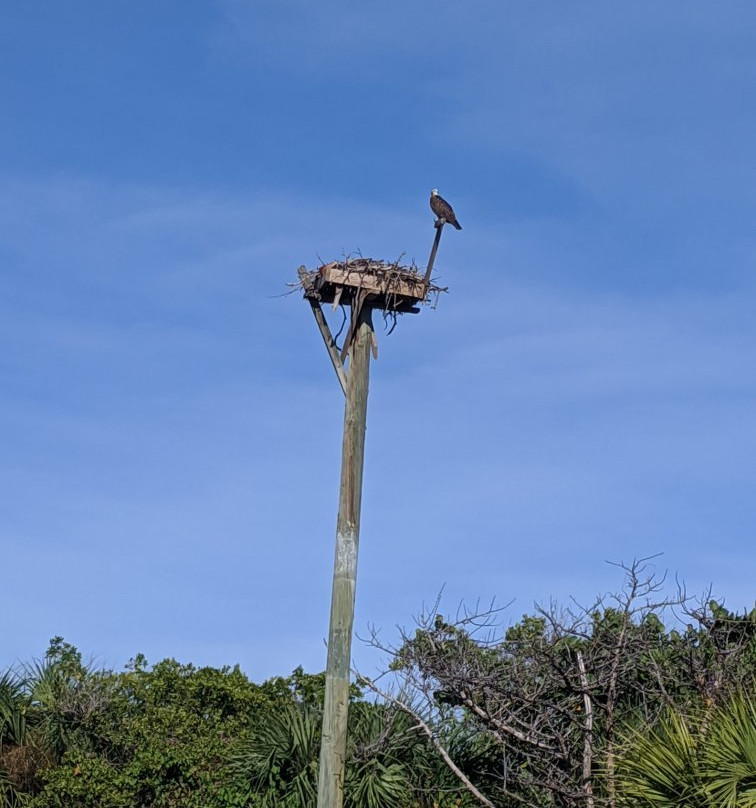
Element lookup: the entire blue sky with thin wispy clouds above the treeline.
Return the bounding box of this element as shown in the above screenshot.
[0,0,756,679]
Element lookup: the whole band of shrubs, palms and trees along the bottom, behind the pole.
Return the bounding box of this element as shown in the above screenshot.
[0,564,756,808]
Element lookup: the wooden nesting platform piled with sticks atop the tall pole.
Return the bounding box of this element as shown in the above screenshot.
[304,258,445,313]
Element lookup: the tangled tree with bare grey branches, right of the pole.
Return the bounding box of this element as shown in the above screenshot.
[363,558,756,808]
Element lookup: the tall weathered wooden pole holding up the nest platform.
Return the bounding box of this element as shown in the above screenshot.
[318,306,373,808]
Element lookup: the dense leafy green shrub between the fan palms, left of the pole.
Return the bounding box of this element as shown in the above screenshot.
[31,657,269,808]
